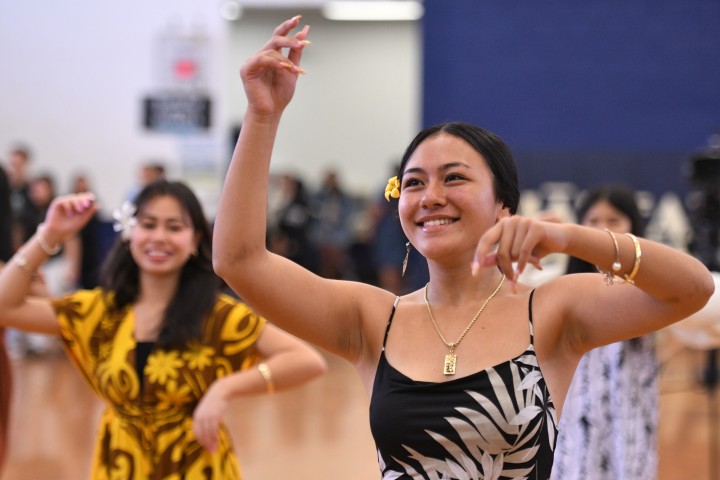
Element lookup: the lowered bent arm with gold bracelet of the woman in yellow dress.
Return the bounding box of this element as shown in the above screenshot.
[193,323,327,452]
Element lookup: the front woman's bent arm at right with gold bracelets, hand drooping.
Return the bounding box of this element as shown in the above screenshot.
[475,216,715,352]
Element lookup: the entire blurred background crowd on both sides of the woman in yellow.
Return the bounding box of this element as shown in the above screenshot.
[0,145,427,358]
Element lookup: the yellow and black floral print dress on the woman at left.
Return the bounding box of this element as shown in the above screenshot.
[54,289,265,480]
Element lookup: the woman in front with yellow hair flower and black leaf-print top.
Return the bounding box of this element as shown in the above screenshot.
[213,17,714,480]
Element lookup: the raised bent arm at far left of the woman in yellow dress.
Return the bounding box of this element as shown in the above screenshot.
[0,194,97,334]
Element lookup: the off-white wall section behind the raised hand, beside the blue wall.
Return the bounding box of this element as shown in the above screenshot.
[227,11,421,200]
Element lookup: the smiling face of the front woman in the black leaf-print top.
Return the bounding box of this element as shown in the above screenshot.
[398,133,510,265]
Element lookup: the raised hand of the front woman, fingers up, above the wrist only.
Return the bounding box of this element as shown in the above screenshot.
[240,16,310,116]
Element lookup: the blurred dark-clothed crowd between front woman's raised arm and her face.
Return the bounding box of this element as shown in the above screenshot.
[268,170,427,294]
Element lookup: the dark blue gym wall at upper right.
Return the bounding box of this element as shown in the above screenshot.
[423,0,720,193]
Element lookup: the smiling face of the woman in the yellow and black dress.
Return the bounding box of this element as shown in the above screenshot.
[130,195,198,276]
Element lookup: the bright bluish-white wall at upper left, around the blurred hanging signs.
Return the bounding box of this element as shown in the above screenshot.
[0,0,232,217]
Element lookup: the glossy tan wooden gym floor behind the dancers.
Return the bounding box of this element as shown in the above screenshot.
[0,336,720,480]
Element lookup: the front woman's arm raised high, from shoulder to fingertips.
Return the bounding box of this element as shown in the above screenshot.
[213,17,392,360]
